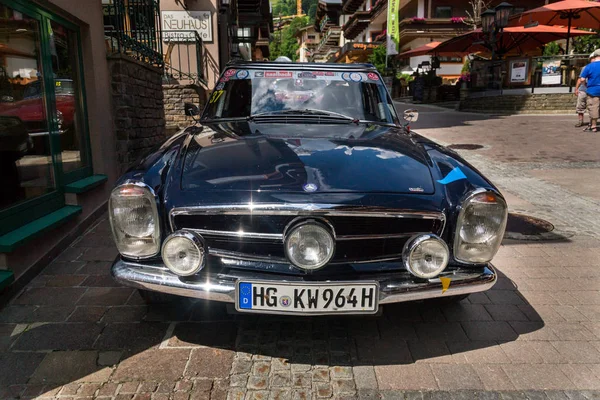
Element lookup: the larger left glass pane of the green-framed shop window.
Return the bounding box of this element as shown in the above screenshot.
[0,6,55,216]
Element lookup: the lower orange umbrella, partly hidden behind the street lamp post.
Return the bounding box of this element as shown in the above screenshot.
[436,25,593,55]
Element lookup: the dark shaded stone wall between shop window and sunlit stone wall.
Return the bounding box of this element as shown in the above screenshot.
[108,55,166,173]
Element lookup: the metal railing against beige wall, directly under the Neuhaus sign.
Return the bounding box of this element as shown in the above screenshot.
[162,30,207,84]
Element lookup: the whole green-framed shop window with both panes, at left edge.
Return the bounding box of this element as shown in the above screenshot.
[0,0,91,235]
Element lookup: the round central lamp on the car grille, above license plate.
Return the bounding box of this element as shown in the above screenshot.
[285,221,335,270]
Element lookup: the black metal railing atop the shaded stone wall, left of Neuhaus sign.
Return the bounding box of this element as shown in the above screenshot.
[102,0,163,67]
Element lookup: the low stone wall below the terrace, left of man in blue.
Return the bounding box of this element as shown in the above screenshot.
[460,93,577,114]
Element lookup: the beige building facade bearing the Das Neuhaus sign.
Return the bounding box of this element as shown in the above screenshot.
[160,0,273,89]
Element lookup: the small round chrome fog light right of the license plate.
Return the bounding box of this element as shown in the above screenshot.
[402,235,450,279]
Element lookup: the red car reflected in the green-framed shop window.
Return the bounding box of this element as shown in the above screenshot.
[0,79,75,150]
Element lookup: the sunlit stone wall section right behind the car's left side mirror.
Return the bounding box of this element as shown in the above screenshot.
[163,84,206,136]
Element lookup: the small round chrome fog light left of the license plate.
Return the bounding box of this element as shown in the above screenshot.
[162,231,205,276]
